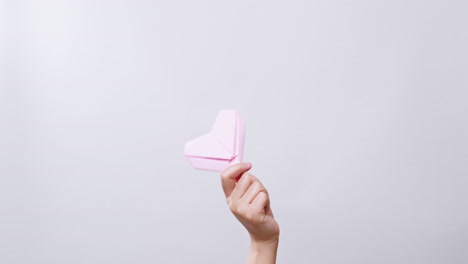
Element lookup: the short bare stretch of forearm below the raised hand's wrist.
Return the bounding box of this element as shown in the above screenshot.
[245,239,278,264]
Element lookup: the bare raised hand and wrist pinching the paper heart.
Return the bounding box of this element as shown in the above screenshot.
[221,162,279,264]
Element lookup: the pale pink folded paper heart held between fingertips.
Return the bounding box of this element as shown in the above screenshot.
[184,110,245,171]
